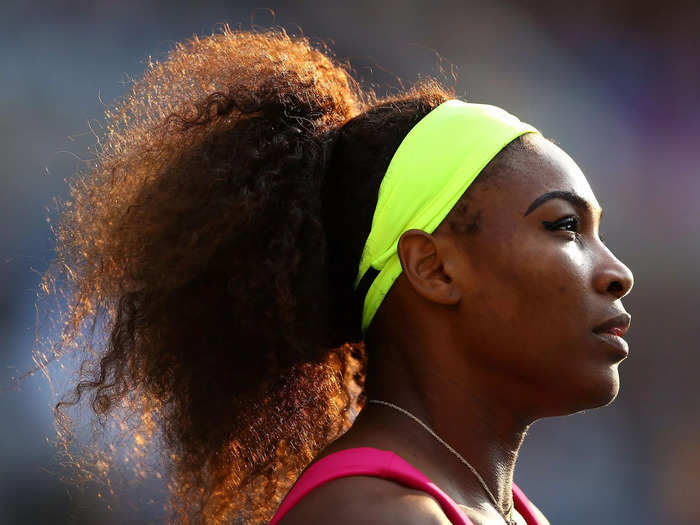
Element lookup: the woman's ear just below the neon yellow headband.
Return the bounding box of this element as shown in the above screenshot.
[397,230,462,304]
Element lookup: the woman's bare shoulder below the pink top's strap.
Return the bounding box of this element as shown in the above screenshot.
[279,476,450,525]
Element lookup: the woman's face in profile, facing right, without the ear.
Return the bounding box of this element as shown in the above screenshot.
[442,135,633,417]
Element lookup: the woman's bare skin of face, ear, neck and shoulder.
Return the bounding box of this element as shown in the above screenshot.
[282,135,633,525]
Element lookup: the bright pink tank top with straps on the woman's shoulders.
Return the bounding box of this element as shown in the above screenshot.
[269,447,545,525]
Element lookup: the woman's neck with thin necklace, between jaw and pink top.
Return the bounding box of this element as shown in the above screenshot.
[356,334,528,511]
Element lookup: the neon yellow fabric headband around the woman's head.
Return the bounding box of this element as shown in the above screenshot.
[355,100,539,334]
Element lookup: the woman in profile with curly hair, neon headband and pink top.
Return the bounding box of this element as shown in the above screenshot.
[47,29,633,525]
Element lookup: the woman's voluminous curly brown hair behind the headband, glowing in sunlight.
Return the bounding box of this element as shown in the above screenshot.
[43,27,460,524]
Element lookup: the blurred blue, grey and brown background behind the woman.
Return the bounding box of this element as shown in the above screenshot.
[0,0,700,525]
